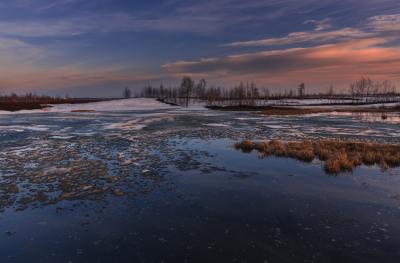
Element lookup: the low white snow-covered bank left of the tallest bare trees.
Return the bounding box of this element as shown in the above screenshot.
[0,98,178,114]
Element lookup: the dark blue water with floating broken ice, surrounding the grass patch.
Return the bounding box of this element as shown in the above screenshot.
[0,110,400,262]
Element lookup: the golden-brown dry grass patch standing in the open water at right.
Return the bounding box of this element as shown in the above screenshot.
[235,140,400,174]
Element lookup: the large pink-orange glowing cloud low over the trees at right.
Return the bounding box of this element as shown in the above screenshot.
[163,38,400,88]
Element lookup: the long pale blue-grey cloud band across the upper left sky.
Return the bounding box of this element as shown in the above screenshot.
[0,13,225,38]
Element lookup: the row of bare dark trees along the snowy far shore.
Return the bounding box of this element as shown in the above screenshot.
[136,77,400,107]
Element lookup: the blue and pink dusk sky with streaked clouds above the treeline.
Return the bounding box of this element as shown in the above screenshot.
[0,0,400,97]
